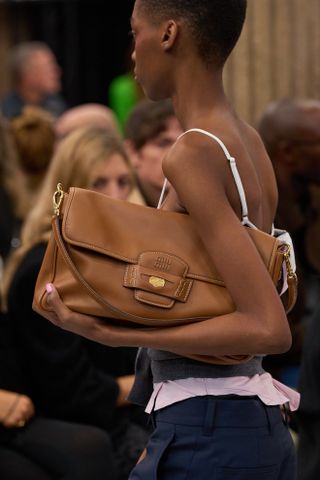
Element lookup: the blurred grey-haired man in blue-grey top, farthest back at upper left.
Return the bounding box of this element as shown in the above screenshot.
[0,42,66,118]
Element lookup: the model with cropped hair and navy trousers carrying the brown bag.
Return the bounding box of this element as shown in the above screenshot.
[47,0,297,480]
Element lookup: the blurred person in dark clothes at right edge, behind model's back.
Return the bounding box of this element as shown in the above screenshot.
[259,100,320,480]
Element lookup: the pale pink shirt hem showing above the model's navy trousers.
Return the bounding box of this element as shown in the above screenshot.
[146,373,300,413]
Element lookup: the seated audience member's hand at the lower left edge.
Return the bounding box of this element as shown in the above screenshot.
[0,390,35,428]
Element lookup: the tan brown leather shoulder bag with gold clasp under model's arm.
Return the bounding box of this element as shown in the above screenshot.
[33,186,296,364]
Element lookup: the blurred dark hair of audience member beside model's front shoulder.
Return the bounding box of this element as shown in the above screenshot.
[125,100,175,150]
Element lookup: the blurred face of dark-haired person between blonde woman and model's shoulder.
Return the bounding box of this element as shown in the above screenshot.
[135,117,182,190]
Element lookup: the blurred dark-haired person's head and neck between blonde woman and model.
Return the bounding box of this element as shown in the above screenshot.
[125,100,182,207]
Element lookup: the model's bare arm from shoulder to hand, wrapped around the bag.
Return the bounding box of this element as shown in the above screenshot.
[45,136,291,355]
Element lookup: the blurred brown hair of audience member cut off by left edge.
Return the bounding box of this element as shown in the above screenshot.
[0,118,27,261]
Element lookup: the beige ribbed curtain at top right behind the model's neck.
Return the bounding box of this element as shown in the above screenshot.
[225,0,320,124]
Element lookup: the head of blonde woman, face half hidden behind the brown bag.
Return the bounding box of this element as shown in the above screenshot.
[2,127,133,268]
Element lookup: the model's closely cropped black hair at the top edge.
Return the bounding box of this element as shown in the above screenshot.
[140,0,247,65]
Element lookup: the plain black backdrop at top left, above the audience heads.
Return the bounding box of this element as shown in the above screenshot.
[5,0,134,106]
